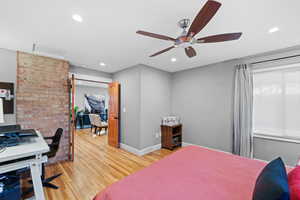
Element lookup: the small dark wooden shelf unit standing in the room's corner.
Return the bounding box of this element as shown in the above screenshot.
[161,124,182,150]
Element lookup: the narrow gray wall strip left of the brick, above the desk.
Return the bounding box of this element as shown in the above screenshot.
[0,49,17,125]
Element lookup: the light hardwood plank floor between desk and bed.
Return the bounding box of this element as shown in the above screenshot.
[45,129,172,200]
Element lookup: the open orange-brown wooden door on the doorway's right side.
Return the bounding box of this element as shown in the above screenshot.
[108,82,120,148]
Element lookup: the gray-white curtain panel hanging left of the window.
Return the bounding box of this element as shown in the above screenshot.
[233,64,253,158]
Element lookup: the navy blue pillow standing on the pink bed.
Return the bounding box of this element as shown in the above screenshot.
[252,158,290,200]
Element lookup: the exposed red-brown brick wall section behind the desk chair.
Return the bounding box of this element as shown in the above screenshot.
[16,52,70,162]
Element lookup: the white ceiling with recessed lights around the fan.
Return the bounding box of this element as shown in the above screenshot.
[0,0,300,72]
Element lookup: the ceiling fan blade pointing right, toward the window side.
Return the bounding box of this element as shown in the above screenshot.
[197,33,243,43]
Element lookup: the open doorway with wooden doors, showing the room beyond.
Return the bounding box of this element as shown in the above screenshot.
[69,74,120,161]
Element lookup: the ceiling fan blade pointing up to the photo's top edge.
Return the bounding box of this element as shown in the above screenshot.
[187,0,222,37]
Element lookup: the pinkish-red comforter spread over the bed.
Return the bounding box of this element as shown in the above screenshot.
[94,146,284,200]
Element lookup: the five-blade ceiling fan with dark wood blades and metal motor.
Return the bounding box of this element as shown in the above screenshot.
[136,0,242,58]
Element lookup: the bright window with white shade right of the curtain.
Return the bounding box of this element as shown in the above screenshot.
[253,64,300,139]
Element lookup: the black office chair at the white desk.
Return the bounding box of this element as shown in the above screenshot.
[23,128,63,195]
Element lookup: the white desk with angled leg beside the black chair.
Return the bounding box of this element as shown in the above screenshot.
[0,132,49,200]
